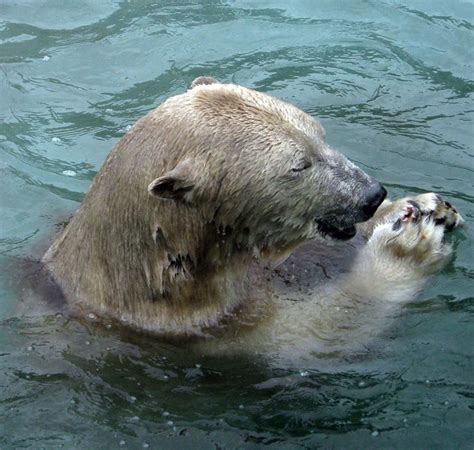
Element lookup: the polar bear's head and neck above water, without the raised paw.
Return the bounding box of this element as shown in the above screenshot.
[43,78,386,335]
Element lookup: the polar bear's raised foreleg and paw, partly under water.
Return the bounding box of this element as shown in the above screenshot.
[196,194,463,362]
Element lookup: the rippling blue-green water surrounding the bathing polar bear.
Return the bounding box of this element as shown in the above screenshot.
[0,0,474,449]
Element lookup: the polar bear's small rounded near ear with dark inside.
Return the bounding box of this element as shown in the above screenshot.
[148,159,194,200]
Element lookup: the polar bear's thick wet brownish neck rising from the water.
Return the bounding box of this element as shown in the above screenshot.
[45,187,260,333]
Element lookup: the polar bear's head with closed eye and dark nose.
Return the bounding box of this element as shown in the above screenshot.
[148,78,386,262]
